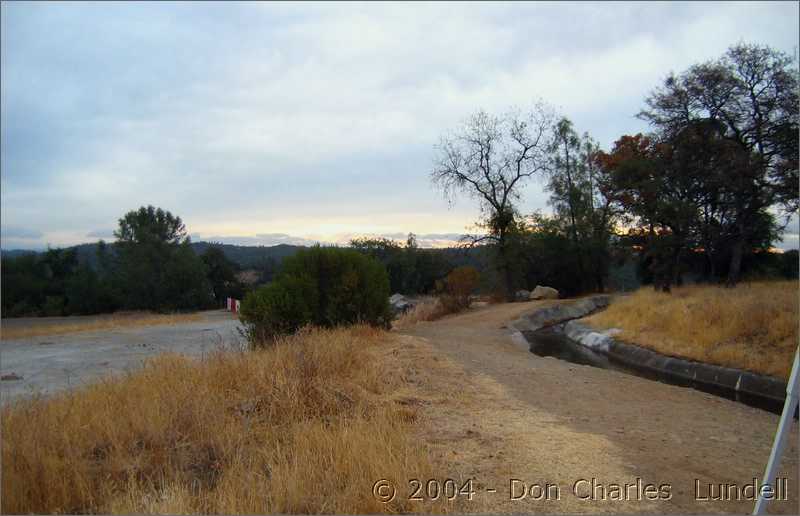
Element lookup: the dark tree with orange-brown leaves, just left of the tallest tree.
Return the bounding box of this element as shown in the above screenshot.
[598,120,776,291]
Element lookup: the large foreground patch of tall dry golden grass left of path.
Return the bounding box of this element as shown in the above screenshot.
[2,327,447,514]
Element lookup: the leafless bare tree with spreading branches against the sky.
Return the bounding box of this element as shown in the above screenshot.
[431,103,554,298]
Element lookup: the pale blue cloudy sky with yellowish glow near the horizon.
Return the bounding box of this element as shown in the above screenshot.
[0,2,800,249]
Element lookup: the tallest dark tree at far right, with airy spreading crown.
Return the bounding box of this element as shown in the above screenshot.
[639,44,800,285]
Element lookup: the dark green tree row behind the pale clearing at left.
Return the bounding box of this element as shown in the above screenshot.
[2,206,243,317]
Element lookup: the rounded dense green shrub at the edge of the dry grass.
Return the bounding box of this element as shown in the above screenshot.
[240,246,391,345]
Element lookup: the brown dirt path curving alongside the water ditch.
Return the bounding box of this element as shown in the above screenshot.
[399,303,799,513]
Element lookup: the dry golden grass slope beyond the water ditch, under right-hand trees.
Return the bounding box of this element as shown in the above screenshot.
[586,281,798,378]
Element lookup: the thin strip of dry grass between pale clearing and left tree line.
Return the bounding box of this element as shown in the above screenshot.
[0,313,206,340]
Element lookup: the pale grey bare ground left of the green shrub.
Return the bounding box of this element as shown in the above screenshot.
[0,310,241,403]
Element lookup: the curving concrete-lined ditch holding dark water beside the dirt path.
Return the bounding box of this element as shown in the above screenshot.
[512,296,797,417]
